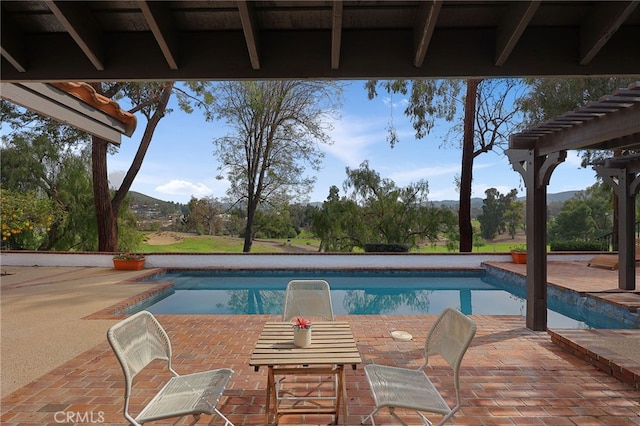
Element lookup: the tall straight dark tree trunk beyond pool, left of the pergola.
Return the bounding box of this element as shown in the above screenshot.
[458,79,482,253]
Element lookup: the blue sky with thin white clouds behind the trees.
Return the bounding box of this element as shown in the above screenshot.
[108,81,595,203]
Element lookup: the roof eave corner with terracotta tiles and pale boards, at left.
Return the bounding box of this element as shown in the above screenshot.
[0,83,136,145]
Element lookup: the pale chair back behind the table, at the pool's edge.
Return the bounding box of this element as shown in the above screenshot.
[282,280,334,321]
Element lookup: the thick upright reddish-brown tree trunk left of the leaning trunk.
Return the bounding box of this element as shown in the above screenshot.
[91,136,118,252]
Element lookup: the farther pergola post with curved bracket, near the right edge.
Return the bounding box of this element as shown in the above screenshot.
[593,158,640,290]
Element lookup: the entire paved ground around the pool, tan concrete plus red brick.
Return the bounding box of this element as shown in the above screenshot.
[0,262,640,425]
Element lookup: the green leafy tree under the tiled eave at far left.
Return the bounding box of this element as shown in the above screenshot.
[0,107,97,251]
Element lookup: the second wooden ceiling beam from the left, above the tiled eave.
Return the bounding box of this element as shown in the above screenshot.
[45,0,105,71]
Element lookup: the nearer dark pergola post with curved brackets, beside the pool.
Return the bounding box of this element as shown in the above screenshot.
[506,149,566,331]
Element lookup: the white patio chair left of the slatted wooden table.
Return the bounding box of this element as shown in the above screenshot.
[107,311,233,426]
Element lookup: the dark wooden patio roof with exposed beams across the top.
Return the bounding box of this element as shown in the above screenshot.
[0,0,640,81]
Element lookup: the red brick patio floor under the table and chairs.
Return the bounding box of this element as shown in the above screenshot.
[0,265,640,425]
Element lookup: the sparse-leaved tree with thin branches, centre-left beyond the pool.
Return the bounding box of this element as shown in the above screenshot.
[213,80,341,252]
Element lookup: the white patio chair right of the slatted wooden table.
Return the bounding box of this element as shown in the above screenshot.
[362,308,476,425]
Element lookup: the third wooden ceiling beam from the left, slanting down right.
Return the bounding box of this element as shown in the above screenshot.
[138,0,178,70]
